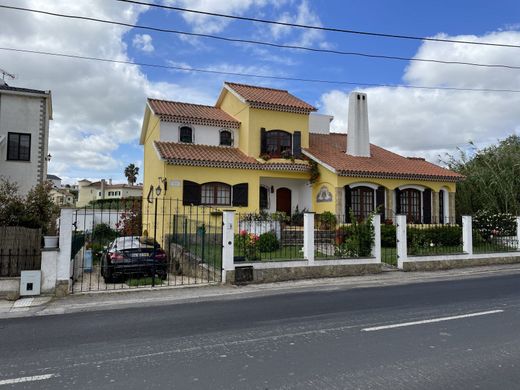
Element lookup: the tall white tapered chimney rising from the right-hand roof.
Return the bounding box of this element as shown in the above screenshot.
[347,92,370,157]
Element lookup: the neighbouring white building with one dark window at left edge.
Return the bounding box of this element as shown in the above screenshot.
[0,80,52,195]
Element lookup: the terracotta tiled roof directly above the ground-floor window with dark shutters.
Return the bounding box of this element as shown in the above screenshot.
[154,141,309,171]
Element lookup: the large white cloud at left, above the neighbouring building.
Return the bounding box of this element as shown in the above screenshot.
[0,0,213,179]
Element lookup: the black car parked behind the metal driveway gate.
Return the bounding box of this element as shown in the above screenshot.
[101,236,168,283]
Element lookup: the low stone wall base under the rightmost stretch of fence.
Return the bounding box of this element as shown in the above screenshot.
[403,256,520,271]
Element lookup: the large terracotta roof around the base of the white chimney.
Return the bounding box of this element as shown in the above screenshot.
[305,133,464,182]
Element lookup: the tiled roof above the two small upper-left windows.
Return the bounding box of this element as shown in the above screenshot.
[148,99,240,129]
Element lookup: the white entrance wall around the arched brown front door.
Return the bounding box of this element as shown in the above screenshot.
[260,177,312,213]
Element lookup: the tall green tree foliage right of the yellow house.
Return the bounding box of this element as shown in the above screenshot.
[440,135,520,215]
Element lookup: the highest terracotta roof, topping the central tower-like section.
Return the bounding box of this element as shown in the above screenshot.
[224,81,316,114]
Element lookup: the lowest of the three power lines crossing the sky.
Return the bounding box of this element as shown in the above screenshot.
[0,47,520,93]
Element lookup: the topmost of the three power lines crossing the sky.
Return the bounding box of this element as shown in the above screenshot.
[116,0,520,49]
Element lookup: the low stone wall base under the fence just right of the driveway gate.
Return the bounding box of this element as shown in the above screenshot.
[224,263,381,284]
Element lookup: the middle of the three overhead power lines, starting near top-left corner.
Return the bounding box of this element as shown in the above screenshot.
[0,5,520,70]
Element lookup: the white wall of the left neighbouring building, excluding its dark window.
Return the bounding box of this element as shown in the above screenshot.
[0,91,48,194]
